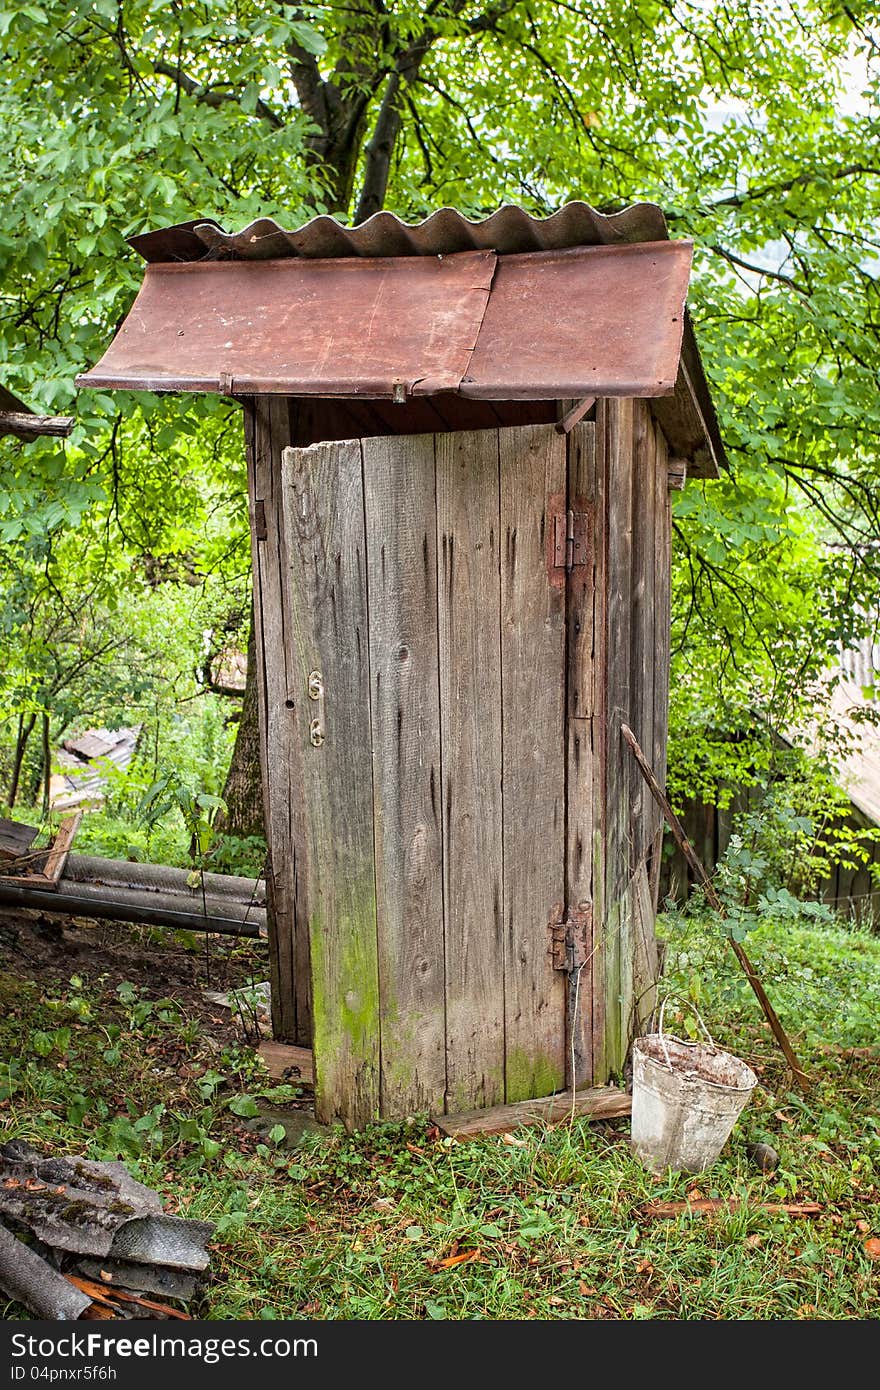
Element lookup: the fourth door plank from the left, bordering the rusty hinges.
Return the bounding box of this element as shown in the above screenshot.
[498,425,566,1102]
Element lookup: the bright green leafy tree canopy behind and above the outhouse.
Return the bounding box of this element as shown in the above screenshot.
[0,0,880,822]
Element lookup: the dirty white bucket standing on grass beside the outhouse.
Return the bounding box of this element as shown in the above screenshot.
[633,1001,758,1173]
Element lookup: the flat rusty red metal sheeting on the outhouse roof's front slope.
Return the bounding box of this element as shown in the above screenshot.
[75,242,691,400]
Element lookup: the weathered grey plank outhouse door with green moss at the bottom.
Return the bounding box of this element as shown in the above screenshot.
[280,425,594,1125]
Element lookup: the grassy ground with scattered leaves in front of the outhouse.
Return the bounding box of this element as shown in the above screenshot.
[0,922,880,1319]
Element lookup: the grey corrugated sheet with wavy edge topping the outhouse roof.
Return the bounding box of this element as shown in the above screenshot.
[128,202,669,263]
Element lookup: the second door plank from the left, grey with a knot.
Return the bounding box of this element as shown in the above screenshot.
[363,435,446,1119]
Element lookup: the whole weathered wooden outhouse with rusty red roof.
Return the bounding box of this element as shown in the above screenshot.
[81,203,723,1126]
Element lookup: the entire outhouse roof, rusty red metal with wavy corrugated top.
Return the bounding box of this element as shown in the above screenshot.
[78,203,724,474]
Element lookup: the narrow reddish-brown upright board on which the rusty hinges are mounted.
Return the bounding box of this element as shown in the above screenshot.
[564,423,605,1086]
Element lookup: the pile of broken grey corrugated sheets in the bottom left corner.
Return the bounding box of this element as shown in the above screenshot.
[0,1140,214,1321]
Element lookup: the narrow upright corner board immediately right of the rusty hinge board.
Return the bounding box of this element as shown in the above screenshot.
[601,399,633,1079]
